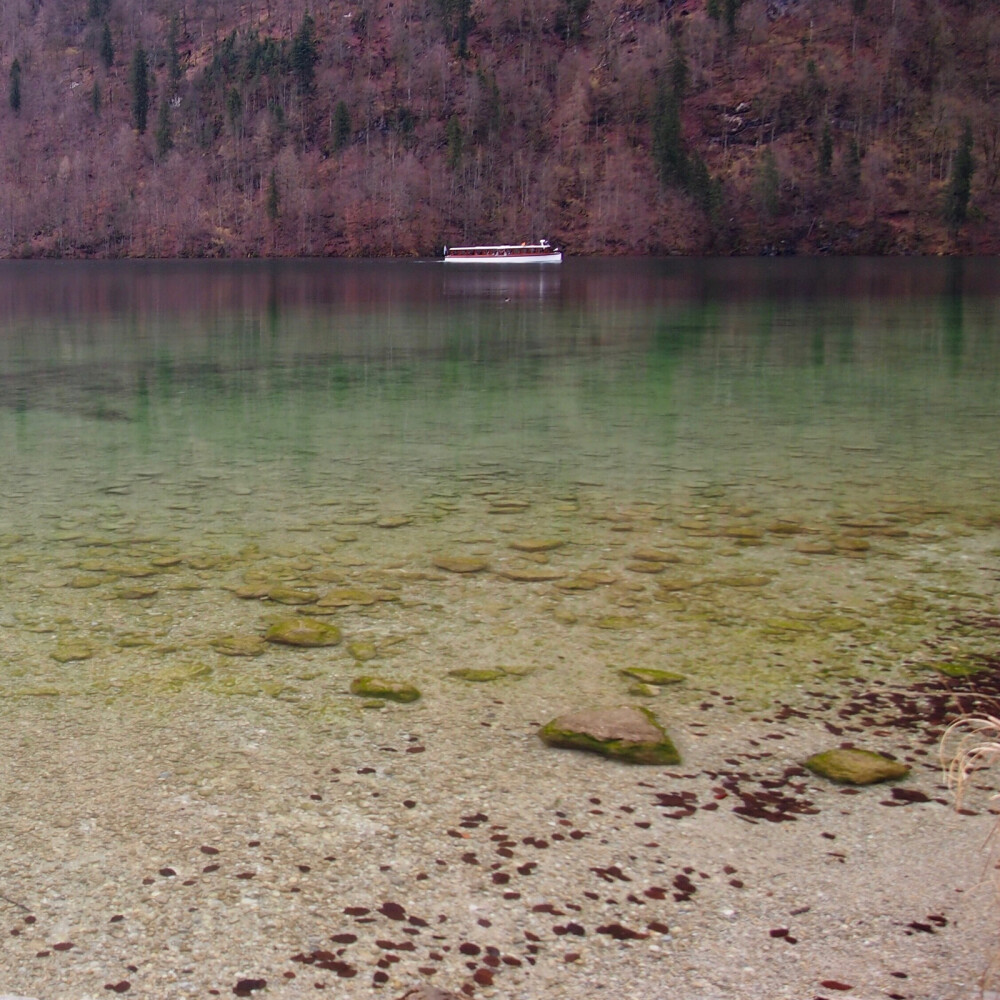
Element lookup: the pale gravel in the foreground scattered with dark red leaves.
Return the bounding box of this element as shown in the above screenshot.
[0,664,995,1000]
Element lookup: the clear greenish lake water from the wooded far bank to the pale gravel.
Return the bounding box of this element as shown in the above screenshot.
[0,260,1000,703]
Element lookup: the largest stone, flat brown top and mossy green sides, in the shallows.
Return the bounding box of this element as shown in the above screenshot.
[538,705,681,764]
